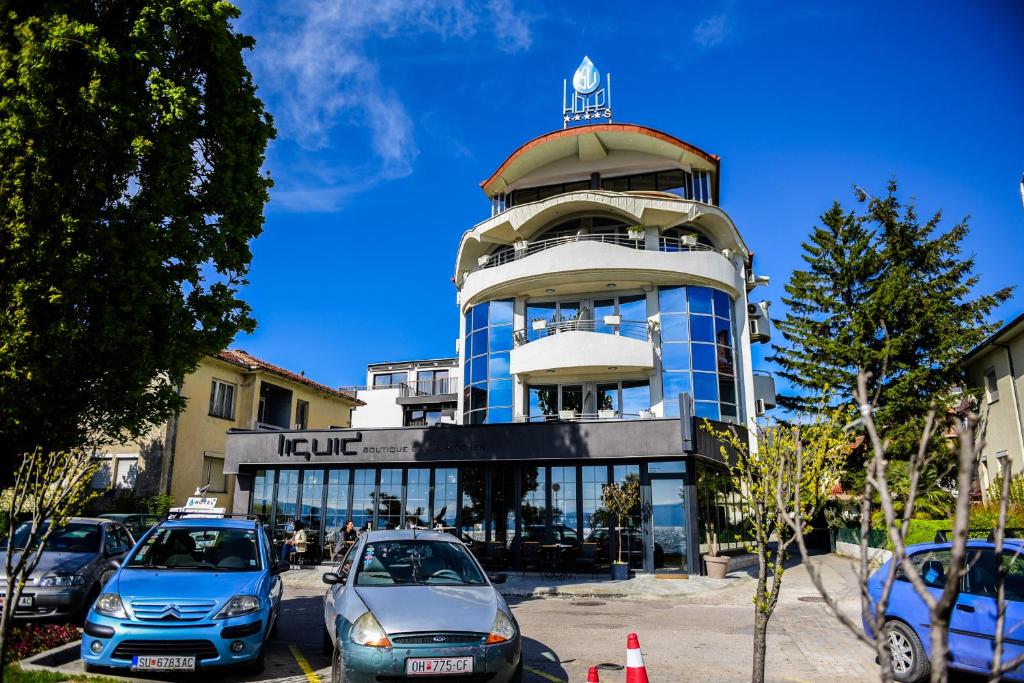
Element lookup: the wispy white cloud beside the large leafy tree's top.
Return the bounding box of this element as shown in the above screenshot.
[241,0,534,206]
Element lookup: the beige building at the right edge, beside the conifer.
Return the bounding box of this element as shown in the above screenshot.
[965,315,1024,492]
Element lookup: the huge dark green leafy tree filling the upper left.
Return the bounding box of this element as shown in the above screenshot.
[0,0,273,464]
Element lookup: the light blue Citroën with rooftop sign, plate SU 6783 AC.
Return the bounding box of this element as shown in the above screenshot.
[82,517,288,673]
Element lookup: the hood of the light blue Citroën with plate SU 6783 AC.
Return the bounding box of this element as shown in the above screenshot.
[117,568,260,603]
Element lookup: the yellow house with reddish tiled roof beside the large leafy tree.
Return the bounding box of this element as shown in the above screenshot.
[92,349,361,509]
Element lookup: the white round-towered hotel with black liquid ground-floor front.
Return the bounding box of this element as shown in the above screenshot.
[226,60,775,572]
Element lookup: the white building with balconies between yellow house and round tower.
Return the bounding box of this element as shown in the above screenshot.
[343,358,461,428]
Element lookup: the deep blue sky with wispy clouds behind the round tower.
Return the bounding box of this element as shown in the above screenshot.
[234,0,1024,385]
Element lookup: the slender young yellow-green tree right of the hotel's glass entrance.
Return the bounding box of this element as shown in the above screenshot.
[702,407,849,683]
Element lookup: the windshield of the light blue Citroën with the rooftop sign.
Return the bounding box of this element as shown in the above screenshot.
[125,526,260,571]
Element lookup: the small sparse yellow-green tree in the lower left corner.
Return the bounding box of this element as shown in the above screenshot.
[0,450,96,663]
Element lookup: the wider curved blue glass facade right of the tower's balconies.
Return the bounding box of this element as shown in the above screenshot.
[658,287,739,422]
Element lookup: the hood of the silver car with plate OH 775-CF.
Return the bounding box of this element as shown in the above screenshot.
[355,586,499,634]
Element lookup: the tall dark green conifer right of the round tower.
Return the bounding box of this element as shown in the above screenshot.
[770,181,1011,460]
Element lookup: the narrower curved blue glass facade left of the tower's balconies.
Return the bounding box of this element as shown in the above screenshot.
[462,299,514,425]
